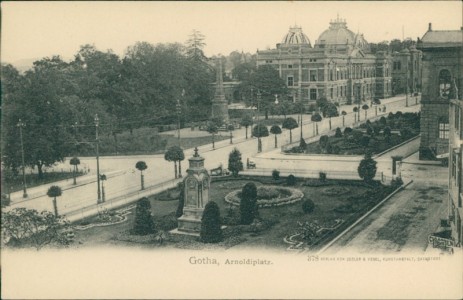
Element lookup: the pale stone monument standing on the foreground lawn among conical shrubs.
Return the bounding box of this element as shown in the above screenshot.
[177,148,211,234]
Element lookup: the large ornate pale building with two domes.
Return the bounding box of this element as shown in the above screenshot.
[257,17,392,104]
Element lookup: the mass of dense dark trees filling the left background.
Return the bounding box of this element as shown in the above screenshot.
[1,31,252,175]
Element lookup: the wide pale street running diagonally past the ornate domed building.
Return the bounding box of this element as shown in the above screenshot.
[8,96,419,219]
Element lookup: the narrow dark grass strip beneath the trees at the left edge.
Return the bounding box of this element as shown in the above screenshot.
[2,172,85,193]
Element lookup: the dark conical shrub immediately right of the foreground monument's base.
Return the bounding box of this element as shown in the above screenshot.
[199,201,223,243]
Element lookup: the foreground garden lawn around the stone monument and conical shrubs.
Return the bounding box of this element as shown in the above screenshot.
[70,178,398,250]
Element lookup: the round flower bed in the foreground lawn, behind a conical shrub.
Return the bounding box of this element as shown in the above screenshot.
[225,186,304,207]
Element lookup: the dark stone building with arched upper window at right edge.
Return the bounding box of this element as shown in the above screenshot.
[417,24,463,160]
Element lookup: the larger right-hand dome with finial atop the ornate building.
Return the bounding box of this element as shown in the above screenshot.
[316,17,355,47]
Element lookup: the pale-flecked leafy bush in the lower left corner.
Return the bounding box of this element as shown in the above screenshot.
[2,207,73,250]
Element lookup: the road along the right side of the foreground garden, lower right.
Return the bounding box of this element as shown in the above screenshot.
[324,159,448,255]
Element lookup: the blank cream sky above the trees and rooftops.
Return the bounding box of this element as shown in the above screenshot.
[1,1,462,63]
